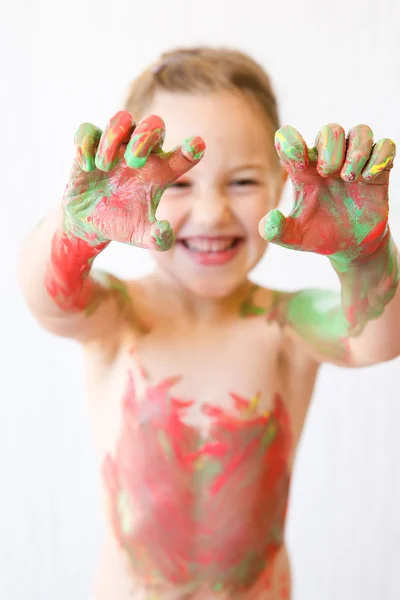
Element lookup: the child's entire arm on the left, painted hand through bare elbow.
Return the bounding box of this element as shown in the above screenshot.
[19,111,205,342]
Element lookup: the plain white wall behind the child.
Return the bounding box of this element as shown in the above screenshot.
[0,0,400,600]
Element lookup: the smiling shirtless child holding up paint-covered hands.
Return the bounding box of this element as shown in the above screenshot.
[20,48,400,600]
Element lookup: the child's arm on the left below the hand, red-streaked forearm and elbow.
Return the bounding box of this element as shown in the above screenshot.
[18,207,133,341]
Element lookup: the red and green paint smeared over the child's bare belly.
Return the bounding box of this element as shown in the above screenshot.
[103,366,291,598]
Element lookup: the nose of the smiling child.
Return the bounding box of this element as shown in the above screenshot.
[191,188,231,229]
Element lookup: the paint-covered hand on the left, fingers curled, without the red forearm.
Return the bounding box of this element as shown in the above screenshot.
[63,110,205,250]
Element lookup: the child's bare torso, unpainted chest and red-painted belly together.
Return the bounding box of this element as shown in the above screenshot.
[86,284,316,600]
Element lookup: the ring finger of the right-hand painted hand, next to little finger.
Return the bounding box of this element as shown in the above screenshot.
[340,125,374,181]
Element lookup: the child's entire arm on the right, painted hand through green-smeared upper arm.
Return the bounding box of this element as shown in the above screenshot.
[262,125,400,366]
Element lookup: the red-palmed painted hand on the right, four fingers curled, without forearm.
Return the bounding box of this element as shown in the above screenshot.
[260,124,396,270]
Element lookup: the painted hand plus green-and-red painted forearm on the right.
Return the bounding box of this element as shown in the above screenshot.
[260,124,399,335]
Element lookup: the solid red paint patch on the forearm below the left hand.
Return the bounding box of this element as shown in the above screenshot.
[44,230,108,311]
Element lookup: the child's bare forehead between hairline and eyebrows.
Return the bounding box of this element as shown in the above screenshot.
[147,91,274,167]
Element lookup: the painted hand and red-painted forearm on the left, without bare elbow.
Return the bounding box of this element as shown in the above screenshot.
[45,110,205,314]
